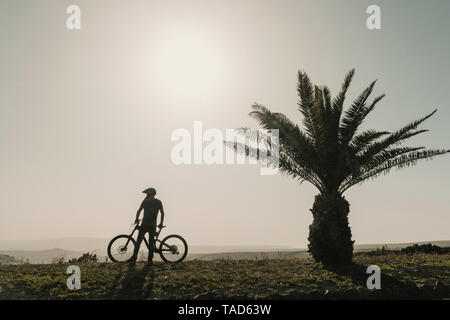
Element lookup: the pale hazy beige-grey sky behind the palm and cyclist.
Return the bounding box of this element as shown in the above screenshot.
[0,0,450,247]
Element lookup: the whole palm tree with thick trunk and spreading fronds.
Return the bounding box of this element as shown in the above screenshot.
[230,70,450,265]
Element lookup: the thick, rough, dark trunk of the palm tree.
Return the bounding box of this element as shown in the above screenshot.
[308,194,354,265]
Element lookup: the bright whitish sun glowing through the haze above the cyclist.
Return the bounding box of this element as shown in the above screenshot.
[154,30,226,99]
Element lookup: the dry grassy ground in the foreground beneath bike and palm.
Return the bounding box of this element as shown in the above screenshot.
[0,252,450,299]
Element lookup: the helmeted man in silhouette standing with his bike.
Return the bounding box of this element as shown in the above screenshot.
[131,188,164,265]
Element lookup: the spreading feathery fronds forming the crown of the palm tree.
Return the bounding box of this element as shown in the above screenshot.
[234,70,450,195]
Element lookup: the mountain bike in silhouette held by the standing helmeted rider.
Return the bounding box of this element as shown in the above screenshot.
[108,220,188,263]
